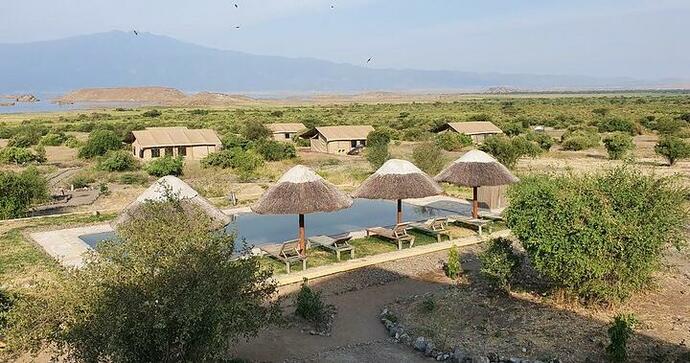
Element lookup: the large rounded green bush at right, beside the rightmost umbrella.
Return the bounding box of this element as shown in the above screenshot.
[504,167,688,302]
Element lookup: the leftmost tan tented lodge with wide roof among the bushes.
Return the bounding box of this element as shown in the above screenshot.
[132,127,223,160]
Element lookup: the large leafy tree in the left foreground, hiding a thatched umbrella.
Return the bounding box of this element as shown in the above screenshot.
[7,200,280,362]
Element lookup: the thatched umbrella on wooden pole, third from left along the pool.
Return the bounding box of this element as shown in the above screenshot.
[352,159,443,223]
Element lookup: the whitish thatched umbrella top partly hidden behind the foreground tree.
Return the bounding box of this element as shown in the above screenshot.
[110,175,231,230]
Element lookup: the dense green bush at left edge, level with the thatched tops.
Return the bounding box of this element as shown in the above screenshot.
[0,167,48,219]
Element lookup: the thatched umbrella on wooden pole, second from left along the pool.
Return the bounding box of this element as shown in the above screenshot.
[251,165,352,251]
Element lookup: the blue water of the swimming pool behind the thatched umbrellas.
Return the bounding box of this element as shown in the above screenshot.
[79,199,466,248]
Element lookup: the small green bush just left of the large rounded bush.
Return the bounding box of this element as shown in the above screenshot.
[479,237,522,290]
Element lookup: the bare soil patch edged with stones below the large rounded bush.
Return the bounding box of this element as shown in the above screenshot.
[389,249,690,362]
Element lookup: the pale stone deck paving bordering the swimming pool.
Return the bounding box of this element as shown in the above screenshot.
[29,195,500,270]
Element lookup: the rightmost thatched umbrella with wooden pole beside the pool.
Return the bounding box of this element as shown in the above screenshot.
[434,150,518,218]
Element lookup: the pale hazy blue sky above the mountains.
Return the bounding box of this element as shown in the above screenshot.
[0,0,690,78]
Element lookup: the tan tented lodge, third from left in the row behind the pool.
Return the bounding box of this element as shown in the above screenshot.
[301,125,374,154]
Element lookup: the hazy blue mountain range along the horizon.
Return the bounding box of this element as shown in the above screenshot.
[0,31,687,93]
